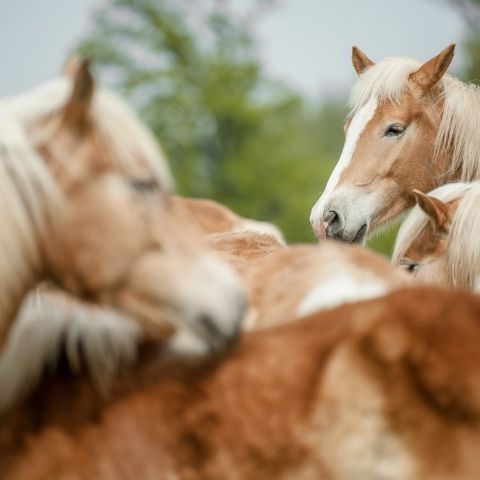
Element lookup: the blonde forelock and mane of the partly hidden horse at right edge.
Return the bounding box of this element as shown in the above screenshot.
[392,182,480,290]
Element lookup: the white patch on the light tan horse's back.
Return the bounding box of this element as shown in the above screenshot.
[297,273,387,316]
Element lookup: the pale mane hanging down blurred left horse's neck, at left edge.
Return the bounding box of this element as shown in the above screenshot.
[0,116,63,318]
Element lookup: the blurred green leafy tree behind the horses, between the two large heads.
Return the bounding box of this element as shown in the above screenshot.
[79,0,345,241]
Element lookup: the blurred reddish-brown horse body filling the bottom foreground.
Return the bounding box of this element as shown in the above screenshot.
[0,288,480,480]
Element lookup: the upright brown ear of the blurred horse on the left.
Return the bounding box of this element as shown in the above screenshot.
[63,57,95,129]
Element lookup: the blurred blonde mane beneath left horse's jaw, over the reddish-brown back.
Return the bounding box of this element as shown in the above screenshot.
[0,288,142,415]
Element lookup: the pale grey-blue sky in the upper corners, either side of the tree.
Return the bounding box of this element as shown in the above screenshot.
[0,0,463,96]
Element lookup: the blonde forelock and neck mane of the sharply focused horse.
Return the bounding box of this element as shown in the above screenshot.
[350,57,480,181]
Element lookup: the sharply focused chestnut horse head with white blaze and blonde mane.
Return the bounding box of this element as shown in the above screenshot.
[310,45,480,242]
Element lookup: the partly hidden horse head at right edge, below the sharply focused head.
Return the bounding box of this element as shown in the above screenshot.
[393,182,480,290]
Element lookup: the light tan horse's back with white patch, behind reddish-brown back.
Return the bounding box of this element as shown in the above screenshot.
[210,236,411,330]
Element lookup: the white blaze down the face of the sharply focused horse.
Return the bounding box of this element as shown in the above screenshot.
[310,98,378,225]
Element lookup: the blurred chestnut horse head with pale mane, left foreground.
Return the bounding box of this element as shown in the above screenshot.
[0,62,245,344]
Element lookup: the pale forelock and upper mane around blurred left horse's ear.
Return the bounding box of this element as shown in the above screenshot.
[0,77,173,191]
